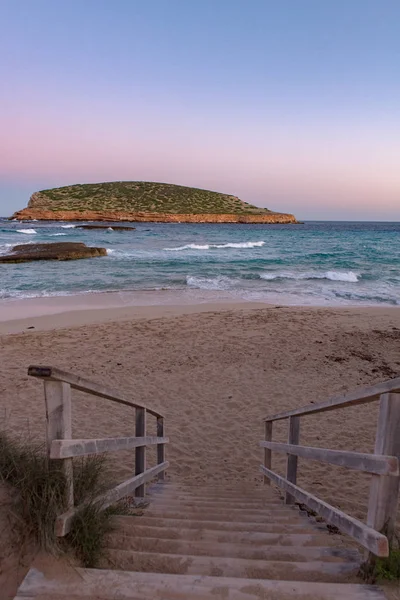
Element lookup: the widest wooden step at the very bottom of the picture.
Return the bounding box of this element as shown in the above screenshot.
[15,569,385,600]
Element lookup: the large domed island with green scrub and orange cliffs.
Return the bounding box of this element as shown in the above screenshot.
[11,181,298,223]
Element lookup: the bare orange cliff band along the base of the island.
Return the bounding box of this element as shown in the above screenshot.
[11,204,298,224]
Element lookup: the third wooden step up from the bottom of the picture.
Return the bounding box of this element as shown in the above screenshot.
[117,513,327,533]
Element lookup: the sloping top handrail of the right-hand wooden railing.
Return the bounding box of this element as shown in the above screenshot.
[264,377,400,421]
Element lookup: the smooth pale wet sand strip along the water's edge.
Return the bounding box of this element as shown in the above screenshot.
[0,290,400,335]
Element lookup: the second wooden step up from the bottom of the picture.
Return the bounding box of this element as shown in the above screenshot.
[106,533,361,563]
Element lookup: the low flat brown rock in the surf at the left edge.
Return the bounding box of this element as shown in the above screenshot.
[0,242,107,263]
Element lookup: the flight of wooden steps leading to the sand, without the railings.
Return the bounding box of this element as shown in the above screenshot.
[15,483,384,600]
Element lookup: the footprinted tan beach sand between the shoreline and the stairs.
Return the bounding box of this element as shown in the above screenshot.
[0,304,400,596]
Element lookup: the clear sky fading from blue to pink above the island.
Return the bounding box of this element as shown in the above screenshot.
[0,0,400,221]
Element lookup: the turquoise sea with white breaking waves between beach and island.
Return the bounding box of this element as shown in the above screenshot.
[0,219,400,306]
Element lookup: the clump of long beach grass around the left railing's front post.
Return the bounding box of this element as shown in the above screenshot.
[0,431,126,567]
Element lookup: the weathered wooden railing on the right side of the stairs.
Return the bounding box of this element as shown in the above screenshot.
[260,377,400,556]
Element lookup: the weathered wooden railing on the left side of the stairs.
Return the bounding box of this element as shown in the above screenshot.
[28,366,169,537]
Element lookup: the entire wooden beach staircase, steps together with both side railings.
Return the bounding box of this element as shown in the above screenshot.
[15,366,400,600]
